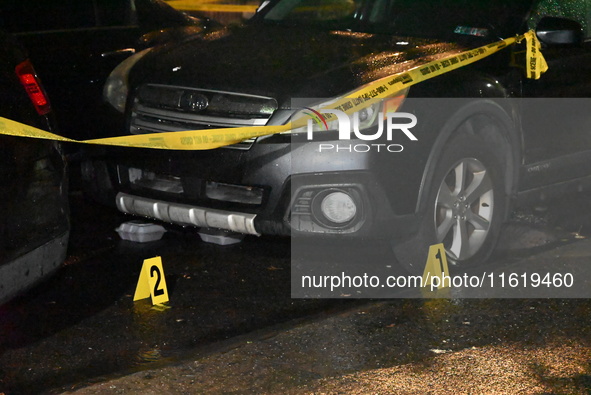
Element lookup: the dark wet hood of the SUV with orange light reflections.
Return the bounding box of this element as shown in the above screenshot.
[130,25,475,103]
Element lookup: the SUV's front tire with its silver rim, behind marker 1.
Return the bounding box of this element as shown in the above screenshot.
[393,127,507,274]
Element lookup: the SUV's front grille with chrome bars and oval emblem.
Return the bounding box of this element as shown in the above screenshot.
[130,85,277,149]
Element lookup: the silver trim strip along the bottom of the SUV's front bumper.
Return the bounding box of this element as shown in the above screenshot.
[115,192,260,236]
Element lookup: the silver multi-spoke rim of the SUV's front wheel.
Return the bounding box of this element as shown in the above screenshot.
[435,158,494,261]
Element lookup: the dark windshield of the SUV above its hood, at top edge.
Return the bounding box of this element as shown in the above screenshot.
[263,0,531,38]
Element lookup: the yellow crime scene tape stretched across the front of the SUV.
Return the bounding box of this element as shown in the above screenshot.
[0,31,548,150]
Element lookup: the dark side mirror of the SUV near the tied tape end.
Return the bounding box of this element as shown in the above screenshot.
[536,16,583,46]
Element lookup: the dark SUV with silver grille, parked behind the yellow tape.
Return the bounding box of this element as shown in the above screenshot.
[85,0,591,272]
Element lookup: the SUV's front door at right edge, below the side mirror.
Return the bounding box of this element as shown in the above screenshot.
[521,0,591,189]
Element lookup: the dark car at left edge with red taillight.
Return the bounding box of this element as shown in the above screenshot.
[0,31,70,303]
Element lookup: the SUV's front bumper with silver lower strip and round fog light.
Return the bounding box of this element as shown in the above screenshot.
[83,136,426,238]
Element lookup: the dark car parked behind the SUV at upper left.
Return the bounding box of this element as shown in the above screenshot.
[0,0,213,139]
